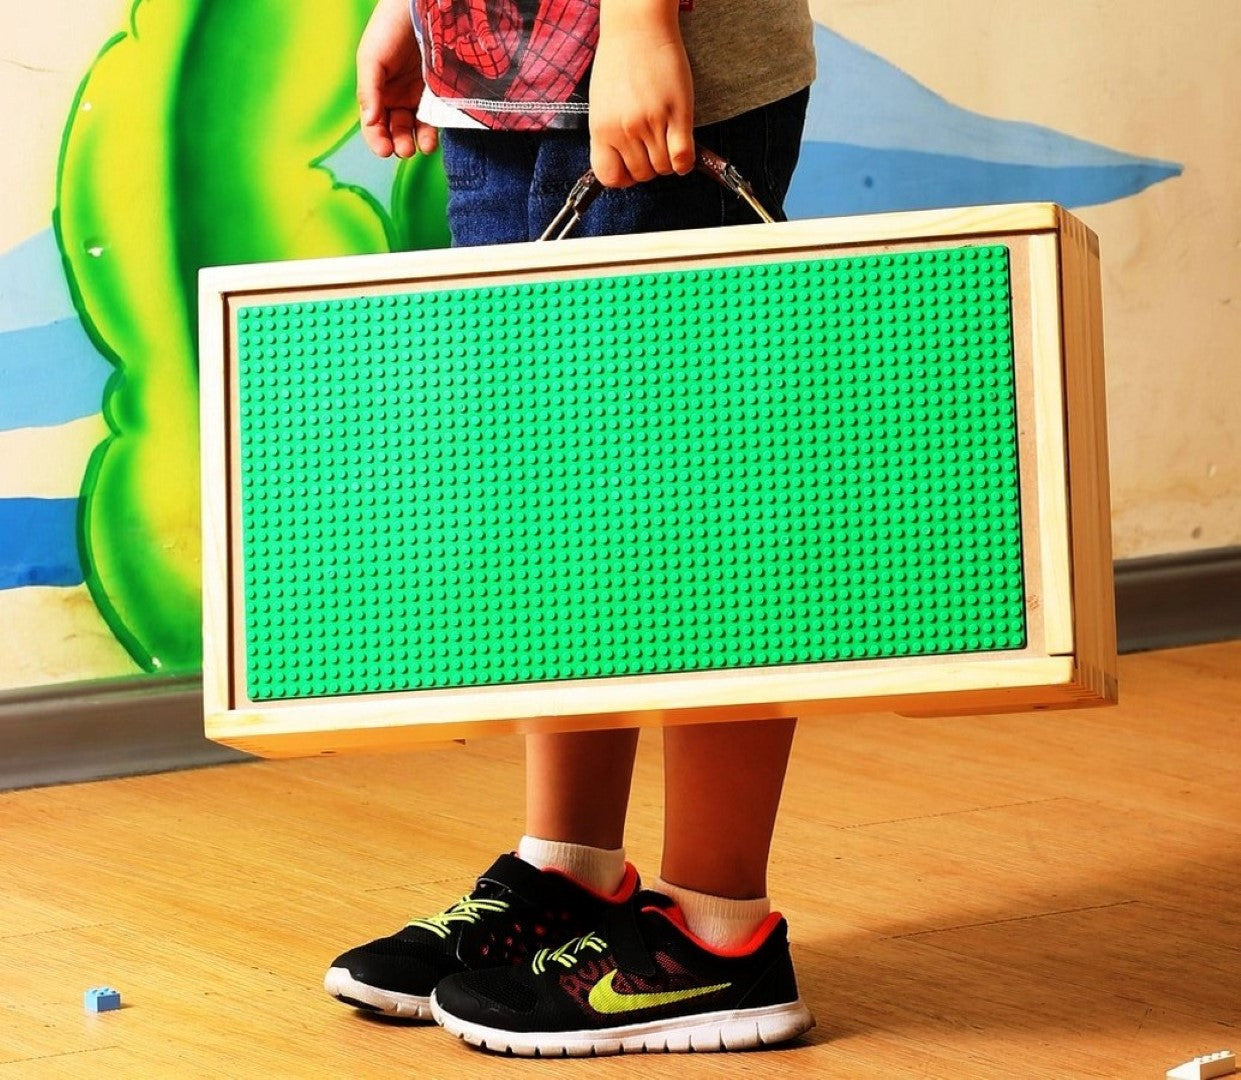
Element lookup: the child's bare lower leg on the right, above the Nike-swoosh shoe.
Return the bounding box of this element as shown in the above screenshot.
[661,720,797,900]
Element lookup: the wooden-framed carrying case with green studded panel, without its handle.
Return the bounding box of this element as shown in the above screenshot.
[200,205,1116,756]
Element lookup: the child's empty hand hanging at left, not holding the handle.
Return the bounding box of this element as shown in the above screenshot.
[357,0,438,158]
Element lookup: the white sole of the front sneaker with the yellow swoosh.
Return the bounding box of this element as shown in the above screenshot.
[431,992,814,1058]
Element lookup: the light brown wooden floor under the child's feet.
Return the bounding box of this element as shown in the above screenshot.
[0,642,1241,1080]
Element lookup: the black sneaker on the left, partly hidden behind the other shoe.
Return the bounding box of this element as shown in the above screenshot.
[323,855,638,1020]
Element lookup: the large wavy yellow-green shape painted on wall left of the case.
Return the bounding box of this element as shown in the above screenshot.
[53,0,388,673]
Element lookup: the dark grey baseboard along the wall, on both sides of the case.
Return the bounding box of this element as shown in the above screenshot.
[0,547,1241,791]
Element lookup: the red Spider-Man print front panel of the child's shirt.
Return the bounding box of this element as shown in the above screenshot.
[412,0,599,132]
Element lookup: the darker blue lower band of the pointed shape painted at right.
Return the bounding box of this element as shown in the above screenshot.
[784,143,1181,217]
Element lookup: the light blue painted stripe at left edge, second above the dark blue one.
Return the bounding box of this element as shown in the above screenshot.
[0,318,113,431]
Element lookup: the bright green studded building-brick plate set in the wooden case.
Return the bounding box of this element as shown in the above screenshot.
[238,246,1026,700]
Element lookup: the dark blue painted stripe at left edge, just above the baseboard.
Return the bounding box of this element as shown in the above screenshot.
[0,499,84,588]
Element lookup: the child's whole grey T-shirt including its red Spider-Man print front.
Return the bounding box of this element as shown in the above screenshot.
[411,0,814,130]
